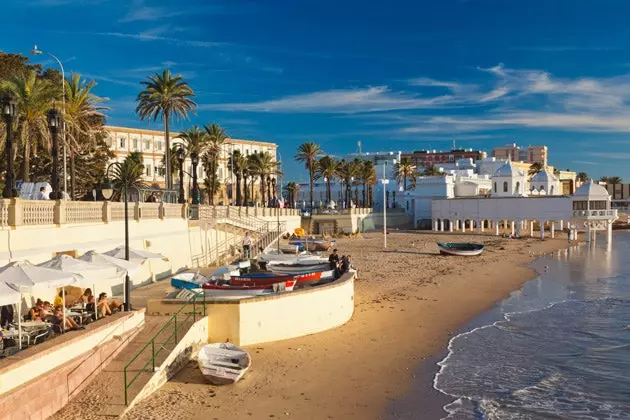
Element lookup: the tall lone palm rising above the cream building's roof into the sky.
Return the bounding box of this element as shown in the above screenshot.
[136,69,197,190]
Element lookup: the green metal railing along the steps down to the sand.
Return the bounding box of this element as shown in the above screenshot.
[123,293,206,406]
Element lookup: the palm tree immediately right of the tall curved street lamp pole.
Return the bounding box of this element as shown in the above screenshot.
[64,74,108,199]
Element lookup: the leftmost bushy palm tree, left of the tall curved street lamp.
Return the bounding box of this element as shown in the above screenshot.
[0,70,61,182]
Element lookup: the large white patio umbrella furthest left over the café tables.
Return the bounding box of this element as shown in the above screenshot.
[0,261,82,349]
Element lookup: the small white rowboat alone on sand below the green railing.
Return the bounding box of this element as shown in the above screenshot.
[197,343,252,385]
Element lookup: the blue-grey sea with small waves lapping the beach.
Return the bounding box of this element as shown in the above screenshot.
[390,232,630,420]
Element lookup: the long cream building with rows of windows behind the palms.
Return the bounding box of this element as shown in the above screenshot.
[105,126,278,200]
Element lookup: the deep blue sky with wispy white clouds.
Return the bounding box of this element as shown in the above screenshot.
[0,0,630,181]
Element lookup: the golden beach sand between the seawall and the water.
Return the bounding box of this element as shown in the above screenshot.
[125,232,567,420]
